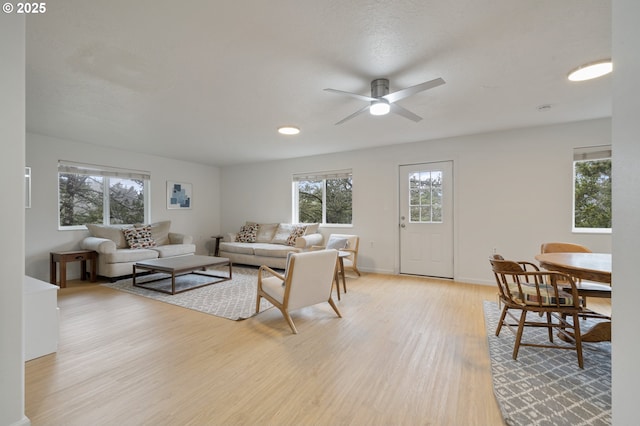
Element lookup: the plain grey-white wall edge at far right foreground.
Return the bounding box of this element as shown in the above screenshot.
[612,0,640,425]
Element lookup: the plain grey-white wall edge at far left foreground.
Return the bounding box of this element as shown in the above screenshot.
[0,13,29,425]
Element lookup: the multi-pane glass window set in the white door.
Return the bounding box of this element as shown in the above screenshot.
[409,170,442,223]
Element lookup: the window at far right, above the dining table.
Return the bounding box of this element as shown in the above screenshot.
[573,145,611,232]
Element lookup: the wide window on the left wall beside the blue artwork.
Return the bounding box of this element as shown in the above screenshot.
[58,161,150,229]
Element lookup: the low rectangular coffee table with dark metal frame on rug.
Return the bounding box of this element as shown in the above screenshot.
[133,255,232,294]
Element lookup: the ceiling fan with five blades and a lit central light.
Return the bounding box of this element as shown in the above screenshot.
[324,78,445,125]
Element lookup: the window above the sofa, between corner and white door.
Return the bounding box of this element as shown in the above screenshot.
[293,170,352,225]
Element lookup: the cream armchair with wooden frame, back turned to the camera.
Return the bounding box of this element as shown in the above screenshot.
[256,250,342,334]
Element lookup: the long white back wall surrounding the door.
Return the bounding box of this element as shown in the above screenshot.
[221,119,611,285]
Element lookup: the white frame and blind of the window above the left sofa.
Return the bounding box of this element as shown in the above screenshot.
[57,160,151,231]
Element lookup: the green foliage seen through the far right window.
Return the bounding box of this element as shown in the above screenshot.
[574,160,611,228]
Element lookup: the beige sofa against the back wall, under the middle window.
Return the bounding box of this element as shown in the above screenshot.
[218,222,323,269]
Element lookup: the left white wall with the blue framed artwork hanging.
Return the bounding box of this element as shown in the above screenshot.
[26,133,220,281]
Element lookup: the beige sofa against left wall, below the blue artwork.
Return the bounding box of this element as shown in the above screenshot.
[81,220,196,281]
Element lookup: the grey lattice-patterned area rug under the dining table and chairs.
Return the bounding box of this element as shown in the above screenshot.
[484,301,611,426]
